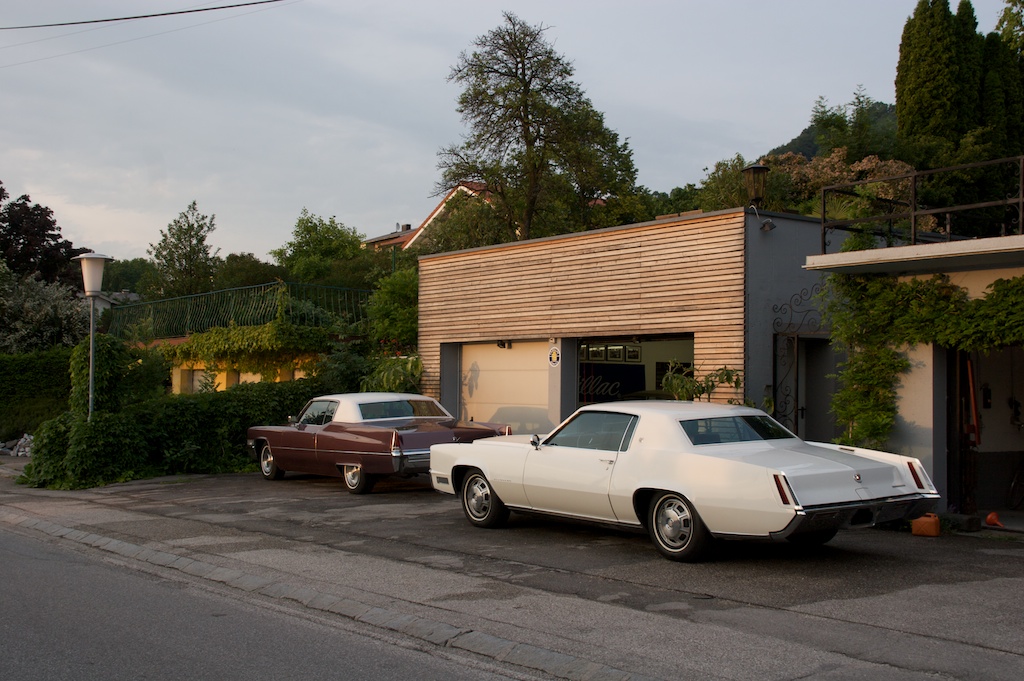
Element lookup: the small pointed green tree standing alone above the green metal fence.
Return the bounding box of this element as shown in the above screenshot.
[146,201,220,298]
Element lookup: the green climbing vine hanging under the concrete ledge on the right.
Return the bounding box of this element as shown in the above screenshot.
[820,274,1024,448]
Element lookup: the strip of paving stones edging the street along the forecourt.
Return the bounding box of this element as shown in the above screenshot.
[0,509,658,681]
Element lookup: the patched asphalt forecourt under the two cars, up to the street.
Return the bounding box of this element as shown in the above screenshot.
[0,464,1024,681]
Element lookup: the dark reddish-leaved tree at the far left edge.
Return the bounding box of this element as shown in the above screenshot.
[0,181,88,289]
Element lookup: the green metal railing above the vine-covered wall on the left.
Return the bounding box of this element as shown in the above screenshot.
[109,282,370,338]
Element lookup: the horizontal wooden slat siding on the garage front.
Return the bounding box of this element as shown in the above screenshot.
[419,210,745,400]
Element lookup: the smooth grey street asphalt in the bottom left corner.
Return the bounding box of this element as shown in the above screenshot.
[0,533,528,681]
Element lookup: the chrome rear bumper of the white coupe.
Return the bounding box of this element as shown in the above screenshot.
[771,494,940,539]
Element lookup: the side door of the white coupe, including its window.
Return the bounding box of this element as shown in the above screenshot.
[523,412,637,520]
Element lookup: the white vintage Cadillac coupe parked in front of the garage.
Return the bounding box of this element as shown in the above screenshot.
[430,401,939,561]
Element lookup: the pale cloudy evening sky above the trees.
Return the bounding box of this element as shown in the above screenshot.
[0,0,1004,260]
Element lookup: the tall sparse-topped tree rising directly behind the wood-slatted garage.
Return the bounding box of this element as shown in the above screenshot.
[438,12,636,241]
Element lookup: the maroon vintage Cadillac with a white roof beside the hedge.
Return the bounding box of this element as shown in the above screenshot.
[248,392,511,495]
